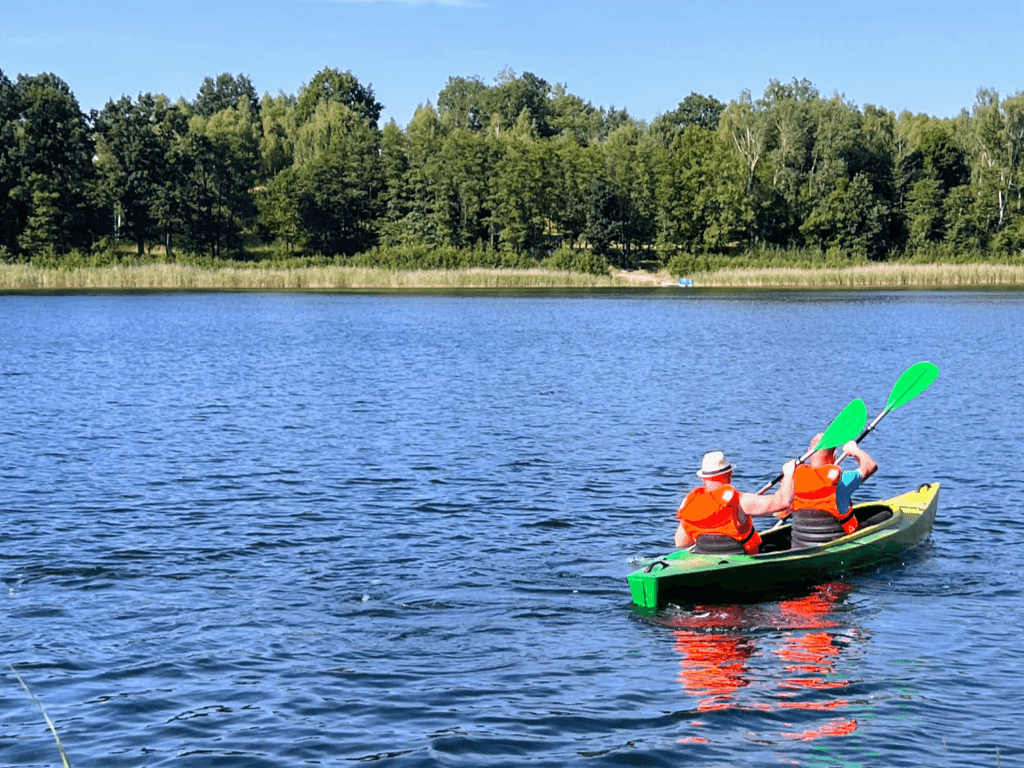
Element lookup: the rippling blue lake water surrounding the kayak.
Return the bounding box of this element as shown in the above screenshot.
[0,291,1024,768]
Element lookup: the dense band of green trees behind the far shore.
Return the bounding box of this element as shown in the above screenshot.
[0,68,1024,273]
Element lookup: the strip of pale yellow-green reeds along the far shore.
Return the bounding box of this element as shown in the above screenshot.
[0,262,1024,293]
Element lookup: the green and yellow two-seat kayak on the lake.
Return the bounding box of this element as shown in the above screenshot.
[628,482,939,611]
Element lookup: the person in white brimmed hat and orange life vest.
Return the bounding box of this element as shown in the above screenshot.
[676,451,796,555]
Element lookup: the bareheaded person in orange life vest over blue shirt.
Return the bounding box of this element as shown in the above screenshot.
[778,433,879,549]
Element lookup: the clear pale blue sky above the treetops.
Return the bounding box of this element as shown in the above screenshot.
[0,0,1024,126]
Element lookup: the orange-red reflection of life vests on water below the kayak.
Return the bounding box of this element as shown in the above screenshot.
[672,583,857,742]
